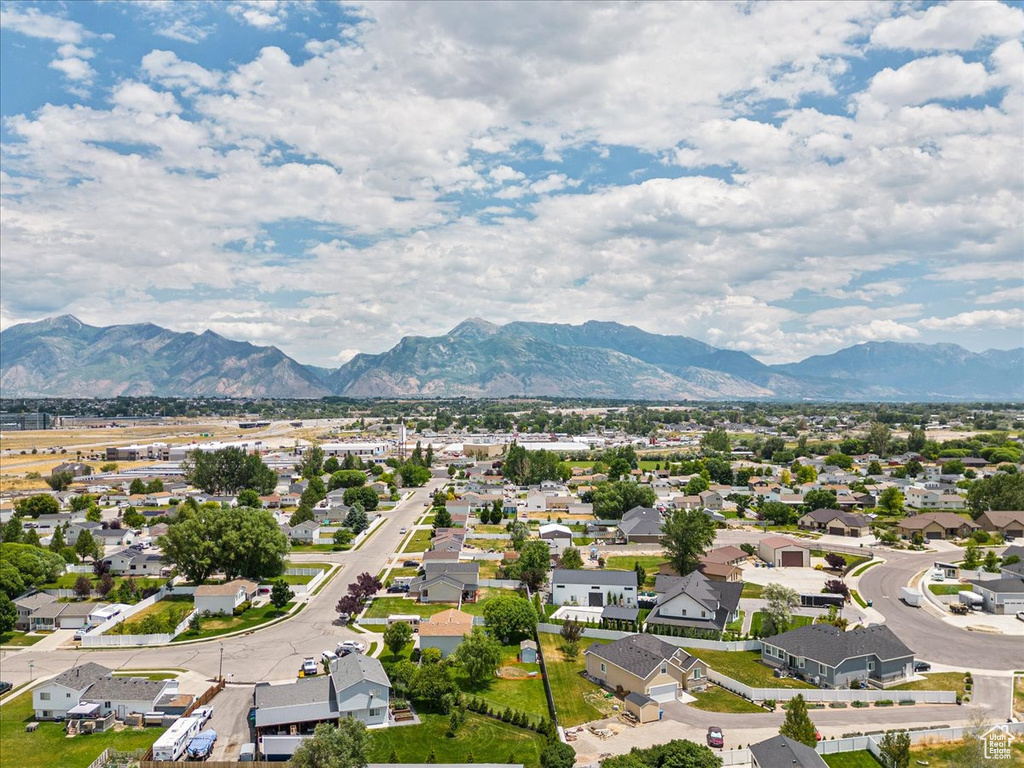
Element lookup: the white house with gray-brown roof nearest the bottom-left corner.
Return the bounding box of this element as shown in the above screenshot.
[32,662,178,720]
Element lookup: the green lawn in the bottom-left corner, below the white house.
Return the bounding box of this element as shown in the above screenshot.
[0,691,164,768]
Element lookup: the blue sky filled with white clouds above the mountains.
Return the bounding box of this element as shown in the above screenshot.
[0,1,1024,365]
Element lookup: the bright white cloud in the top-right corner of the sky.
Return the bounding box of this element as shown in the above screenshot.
[871,0,1024,50]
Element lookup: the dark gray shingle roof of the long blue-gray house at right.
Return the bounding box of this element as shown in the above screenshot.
[764,624,913,667]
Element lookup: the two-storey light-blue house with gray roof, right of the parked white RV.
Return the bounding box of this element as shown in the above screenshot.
[253,653,391,736]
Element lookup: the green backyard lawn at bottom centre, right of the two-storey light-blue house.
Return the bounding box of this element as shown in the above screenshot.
[367,712,544,768]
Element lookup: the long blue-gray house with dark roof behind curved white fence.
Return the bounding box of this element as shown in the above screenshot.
[761,624,913,688]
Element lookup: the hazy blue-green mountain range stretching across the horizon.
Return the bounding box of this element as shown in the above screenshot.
[0,315,1024,400]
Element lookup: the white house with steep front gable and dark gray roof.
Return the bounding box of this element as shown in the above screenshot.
[647,570,743,633]
